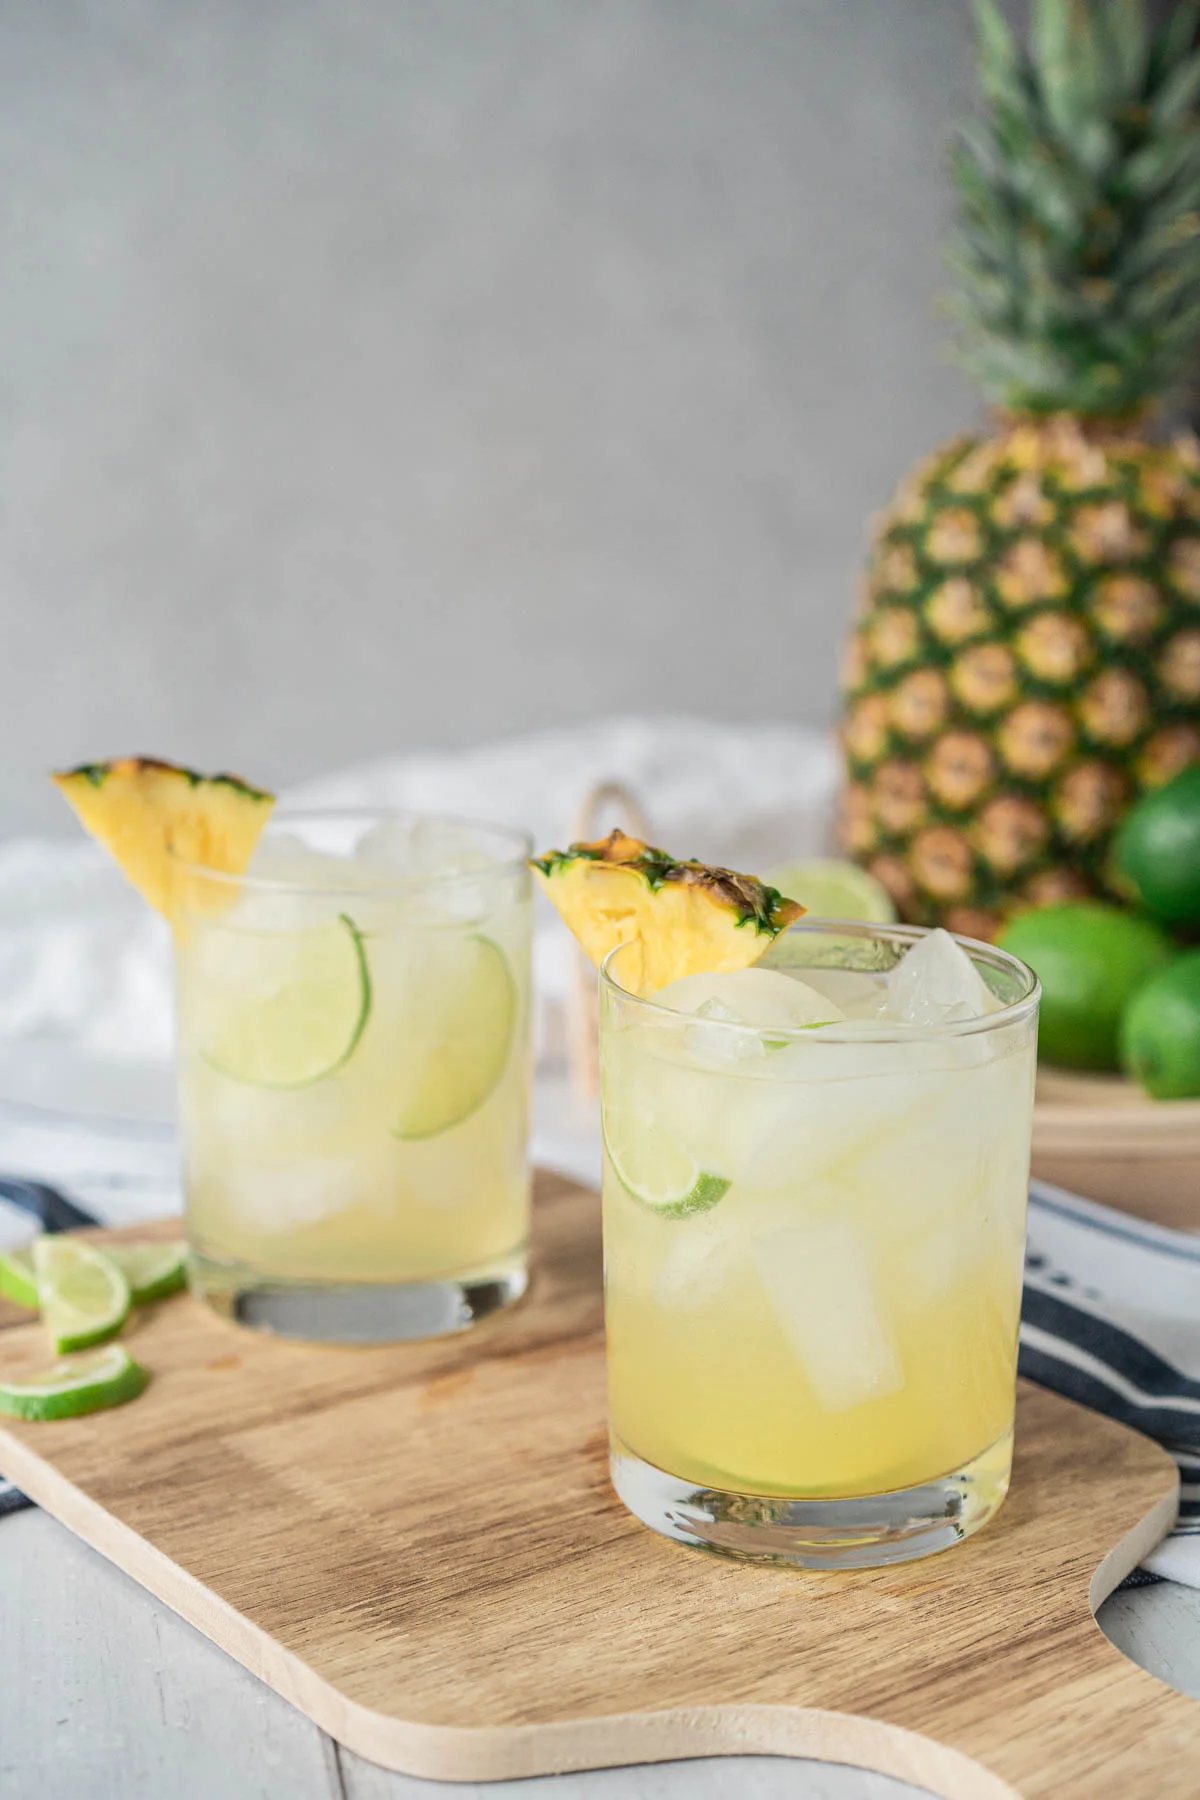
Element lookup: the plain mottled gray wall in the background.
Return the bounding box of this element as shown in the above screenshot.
[0,0,973,830]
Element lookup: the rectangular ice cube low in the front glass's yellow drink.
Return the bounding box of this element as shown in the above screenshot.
[754,1217,905,1413]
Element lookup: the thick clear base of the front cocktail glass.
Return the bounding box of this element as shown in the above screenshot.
[610,1431,1013,1570]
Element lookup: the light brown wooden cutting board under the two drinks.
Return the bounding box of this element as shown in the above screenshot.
[0,1177,1200,1800]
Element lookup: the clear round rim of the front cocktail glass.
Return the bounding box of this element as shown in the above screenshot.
[599,918,1042,1044]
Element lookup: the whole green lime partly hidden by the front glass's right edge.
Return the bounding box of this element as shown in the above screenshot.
[997,900,1177,1069]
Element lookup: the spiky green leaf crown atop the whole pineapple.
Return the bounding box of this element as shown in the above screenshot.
[950,0,1200,418]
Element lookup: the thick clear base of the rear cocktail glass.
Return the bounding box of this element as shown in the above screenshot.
[191,1247,529,1345]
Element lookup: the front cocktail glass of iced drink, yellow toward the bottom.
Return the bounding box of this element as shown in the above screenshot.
[601,922,1040,1568]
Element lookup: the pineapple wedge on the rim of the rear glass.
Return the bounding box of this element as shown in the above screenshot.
[54,756,275,918]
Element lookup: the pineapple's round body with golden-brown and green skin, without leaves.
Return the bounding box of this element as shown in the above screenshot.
[838,414,1200,938]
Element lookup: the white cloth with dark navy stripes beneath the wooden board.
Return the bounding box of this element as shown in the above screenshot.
[0,1118,1200,1588]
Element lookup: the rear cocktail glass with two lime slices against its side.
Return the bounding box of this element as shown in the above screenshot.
[175,812,531,1343]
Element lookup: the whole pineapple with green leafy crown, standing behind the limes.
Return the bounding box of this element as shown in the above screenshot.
[842,0,1200,938]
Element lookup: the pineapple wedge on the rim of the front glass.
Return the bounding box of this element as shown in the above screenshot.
[531,832,804,995]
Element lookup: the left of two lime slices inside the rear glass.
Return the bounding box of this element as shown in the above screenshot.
[201,913,371,1087]
